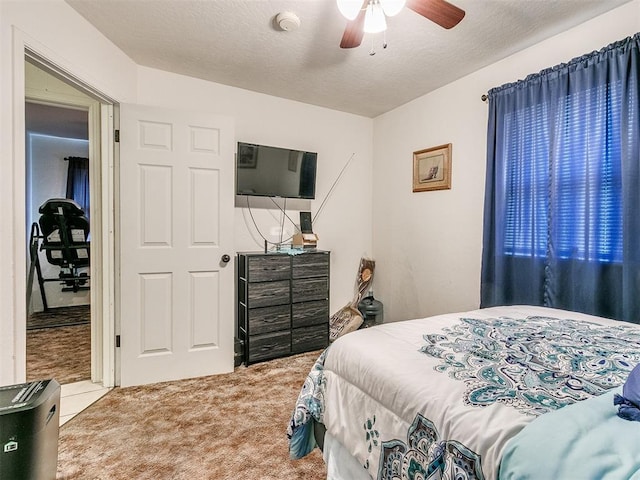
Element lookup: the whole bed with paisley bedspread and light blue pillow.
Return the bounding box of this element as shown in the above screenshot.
[287,306,640,480]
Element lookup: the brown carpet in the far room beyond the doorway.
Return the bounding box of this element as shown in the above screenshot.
[27,324,91,384]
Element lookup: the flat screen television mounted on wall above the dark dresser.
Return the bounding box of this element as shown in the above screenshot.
[236,142,318,199]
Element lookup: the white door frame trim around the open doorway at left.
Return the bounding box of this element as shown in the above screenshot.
[8,28,117,387]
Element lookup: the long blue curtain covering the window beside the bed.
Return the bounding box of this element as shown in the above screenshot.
[481,34,640,323]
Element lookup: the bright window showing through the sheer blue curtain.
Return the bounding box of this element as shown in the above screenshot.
[504,82,622,262]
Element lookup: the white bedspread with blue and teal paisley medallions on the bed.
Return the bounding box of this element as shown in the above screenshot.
[288,307,640,480]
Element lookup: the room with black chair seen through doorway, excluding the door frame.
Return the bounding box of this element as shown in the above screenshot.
[25,98,91,384]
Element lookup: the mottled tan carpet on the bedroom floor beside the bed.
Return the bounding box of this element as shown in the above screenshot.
[57,352,326,480]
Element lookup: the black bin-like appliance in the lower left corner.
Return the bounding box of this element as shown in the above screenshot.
[0,379,60,480]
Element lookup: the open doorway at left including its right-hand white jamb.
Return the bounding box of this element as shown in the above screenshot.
[24,50,115,395]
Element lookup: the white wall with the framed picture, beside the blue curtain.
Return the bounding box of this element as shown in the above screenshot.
[373,0,640,321]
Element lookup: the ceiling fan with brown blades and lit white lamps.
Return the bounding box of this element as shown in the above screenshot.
[337,0,465,48]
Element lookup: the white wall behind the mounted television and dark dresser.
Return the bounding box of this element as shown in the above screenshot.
[138,67,373,313]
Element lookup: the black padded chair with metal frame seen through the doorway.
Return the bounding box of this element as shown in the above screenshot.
[27,198,90,311]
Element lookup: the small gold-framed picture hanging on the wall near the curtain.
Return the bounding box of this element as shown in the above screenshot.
[413,143,451,192]
